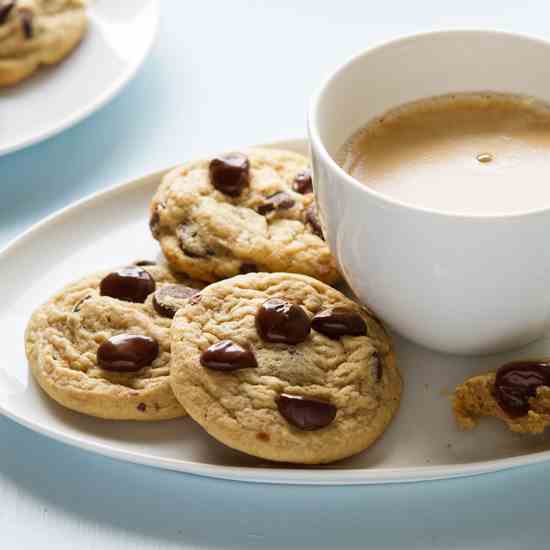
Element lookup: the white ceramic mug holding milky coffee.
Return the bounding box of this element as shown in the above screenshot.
[308,31,550,354]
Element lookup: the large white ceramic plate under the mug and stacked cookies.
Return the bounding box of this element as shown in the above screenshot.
[0,141,550,485]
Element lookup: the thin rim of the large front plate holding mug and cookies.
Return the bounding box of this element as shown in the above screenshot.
[0,138,550,486]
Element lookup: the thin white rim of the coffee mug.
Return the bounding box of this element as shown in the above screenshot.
[307,28,550,221]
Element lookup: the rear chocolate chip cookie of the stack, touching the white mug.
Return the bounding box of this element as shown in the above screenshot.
[150,149,339,284]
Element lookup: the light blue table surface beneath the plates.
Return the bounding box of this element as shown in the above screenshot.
[0,0,550,550]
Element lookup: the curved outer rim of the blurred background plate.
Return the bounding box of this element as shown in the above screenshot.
[0,0,160,157]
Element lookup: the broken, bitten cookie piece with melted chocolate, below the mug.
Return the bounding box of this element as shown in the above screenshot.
[453,360,550,434]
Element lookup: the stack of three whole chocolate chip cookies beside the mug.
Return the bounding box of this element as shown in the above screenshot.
[26,149,401,464]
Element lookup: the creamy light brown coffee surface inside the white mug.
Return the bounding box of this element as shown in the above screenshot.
[337,93,550,215]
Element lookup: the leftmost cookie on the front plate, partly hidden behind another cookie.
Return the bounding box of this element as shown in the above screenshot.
[25,262,203,420]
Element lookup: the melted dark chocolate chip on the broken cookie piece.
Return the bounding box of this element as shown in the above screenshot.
[494,361,550,417]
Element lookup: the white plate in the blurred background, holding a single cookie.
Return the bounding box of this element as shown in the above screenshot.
[0,0,159,155]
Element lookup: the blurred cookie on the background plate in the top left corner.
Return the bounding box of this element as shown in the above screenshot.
[0,0,87,86]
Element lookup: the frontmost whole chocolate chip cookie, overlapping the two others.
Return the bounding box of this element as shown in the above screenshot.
[170,273,401,464]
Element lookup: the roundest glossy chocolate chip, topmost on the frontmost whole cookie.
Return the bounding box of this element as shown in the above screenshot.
[256,298,311,344]
